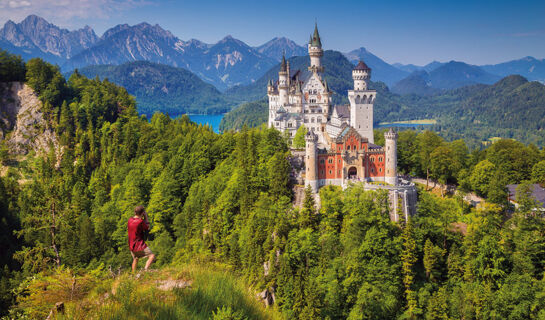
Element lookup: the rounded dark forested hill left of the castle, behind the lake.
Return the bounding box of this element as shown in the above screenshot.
[74,61,230,116]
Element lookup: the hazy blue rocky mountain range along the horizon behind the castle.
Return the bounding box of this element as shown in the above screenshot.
[0,15,545,94]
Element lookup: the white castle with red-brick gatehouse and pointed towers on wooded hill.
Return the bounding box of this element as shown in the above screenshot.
[267,25,416,220]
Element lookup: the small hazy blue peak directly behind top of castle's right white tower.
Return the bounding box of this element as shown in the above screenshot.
[345,47,409,86]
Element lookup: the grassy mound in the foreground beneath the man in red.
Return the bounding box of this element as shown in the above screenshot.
[51,265,283,320]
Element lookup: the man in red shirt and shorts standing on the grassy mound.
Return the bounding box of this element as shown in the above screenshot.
[127,206,155,272]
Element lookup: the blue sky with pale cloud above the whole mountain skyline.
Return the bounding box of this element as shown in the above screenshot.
[0,0,545,65]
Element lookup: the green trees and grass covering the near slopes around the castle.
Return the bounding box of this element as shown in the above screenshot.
[0,49,545,320]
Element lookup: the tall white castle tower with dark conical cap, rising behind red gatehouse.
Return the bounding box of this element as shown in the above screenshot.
[348,61,377,143]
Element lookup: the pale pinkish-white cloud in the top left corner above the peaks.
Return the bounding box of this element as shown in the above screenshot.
[0,0,150,27]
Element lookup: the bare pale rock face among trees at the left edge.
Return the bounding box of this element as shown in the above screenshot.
[0,82,59,155]
